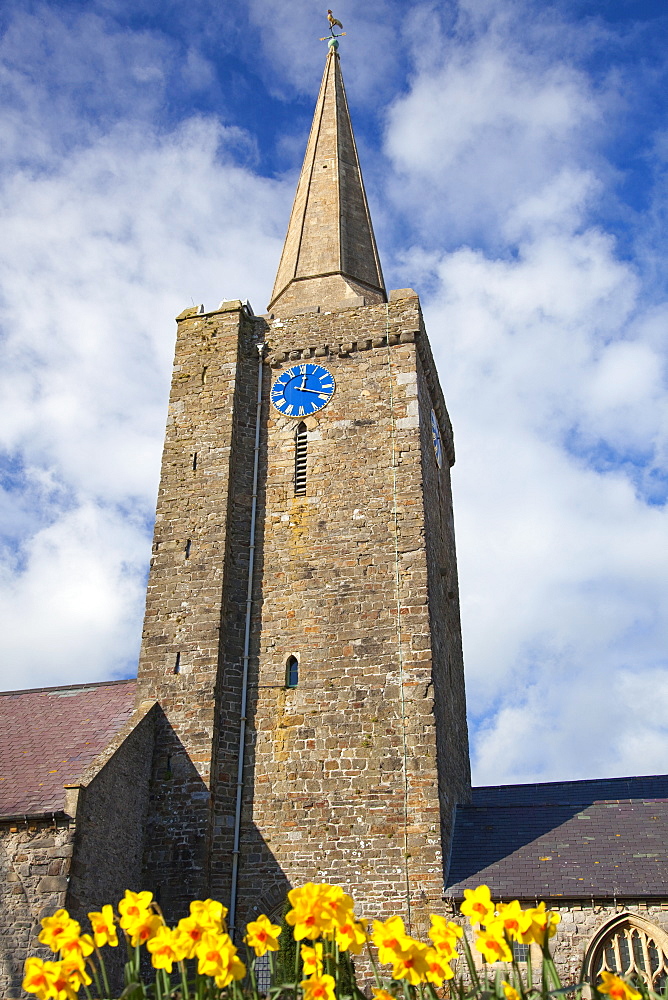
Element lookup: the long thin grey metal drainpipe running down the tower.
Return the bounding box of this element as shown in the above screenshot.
[229,344,265,939]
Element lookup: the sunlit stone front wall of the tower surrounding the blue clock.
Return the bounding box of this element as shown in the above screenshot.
[217,292,468,930]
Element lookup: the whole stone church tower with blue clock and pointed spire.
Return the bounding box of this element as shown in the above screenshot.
[138,40,470,932]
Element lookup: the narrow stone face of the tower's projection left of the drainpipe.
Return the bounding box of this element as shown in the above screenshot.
[137,302,258,919]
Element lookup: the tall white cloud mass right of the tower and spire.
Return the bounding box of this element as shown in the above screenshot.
[387,4,668,783]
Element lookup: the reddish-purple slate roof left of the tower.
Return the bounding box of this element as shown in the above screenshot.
[0,680,136,818]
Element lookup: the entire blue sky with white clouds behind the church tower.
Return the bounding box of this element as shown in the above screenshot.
[0,0,668,782]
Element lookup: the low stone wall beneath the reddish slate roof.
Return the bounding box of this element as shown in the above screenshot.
[0,816,73,998]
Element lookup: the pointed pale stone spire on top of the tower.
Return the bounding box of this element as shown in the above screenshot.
[268,43,387,315]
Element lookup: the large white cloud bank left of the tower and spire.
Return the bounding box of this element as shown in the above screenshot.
[0,9,285,688]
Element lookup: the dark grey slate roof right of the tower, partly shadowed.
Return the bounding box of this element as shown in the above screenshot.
[446,775,668,900]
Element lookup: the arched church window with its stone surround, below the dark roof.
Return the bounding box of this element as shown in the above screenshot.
[583,913,668,994]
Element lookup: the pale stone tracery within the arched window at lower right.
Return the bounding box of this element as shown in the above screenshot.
[592,918,668,993]
